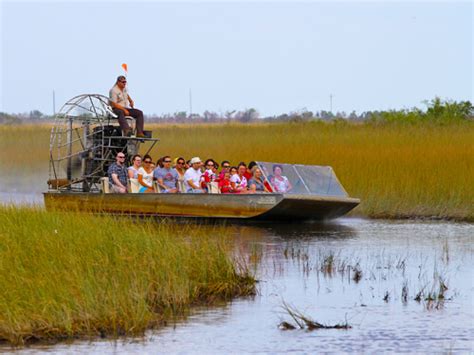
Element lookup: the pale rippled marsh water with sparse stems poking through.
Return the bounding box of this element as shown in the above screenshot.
[2,195,474,354]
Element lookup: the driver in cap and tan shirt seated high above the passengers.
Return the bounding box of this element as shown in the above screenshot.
[109,75,145,138]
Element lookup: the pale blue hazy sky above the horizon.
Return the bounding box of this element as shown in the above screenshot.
[0,1,474,115]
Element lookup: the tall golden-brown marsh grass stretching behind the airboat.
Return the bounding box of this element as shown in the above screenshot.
[0,121,474,221]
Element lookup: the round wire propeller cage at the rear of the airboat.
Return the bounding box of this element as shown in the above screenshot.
[48,94,156,192]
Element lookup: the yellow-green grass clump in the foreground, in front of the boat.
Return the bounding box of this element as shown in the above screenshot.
[0,207,255,345]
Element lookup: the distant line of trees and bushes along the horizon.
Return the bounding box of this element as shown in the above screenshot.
[0,97,474,124]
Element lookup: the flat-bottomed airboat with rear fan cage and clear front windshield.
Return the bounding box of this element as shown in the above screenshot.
[44,94,360,220]
